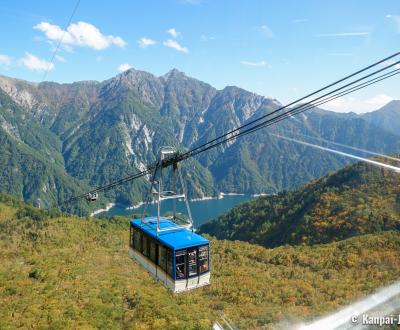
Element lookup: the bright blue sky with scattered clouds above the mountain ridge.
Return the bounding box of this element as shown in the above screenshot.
[0,0,400,113]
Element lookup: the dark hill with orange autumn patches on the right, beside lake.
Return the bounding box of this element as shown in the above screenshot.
[200,160,400,247]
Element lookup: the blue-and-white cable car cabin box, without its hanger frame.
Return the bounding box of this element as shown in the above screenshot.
[129,217,210,292]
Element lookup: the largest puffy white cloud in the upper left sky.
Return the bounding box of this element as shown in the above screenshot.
[33,22,126,50]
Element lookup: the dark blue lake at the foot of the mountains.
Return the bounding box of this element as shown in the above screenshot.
[100,195,254,227]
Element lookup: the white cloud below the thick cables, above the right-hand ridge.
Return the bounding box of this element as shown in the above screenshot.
[321,94,393,113]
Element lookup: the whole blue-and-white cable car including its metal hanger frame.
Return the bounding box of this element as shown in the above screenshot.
[129,147,211,292]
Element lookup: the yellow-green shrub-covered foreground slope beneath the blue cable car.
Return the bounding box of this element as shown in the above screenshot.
[0,195,400,329]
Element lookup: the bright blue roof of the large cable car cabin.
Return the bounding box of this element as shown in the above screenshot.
[131,217,209,250]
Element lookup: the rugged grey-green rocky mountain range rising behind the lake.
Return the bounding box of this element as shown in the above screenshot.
[0,69,400,214]
